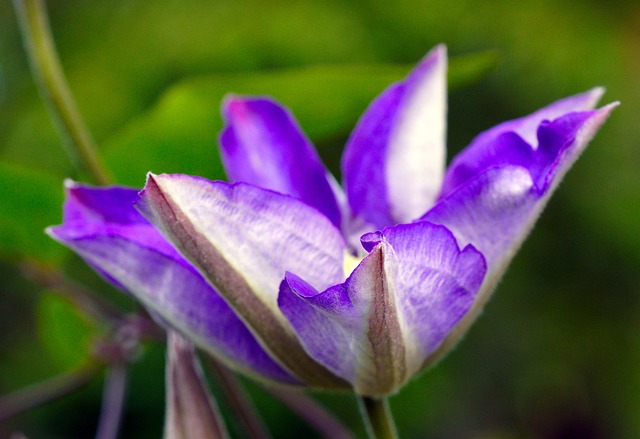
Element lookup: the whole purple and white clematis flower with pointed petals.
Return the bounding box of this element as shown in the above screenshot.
[49,46,616,396]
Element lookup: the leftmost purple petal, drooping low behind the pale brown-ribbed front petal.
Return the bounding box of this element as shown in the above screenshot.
[47,181,297,383]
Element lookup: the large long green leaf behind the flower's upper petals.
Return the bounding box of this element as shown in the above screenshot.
[104,52,496,187]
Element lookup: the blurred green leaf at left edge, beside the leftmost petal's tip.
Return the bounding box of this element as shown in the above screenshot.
[0,162,64,262]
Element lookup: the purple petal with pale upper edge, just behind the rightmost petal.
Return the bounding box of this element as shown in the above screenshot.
[440,88,604,197]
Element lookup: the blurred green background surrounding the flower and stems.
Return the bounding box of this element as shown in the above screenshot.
[0,0,640,439]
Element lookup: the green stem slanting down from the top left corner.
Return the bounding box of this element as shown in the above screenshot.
[14,0,111,185]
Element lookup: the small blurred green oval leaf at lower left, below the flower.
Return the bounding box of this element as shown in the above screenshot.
[36,293,94,370]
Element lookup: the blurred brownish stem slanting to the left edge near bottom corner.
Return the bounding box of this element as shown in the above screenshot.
[0,364,102,422]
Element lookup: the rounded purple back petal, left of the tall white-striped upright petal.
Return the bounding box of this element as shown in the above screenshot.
[220,96,341,228]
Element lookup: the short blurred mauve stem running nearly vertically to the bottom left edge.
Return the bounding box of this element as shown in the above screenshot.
[96,364,127,439]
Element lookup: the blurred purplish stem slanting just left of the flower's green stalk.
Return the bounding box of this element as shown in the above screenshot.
[266,386,354,439]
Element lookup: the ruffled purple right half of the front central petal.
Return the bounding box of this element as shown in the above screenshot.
[362,221,487,375]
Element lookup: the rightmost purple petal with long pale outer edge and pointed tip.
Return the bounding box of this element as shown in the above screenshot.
[422,100,617,368]
